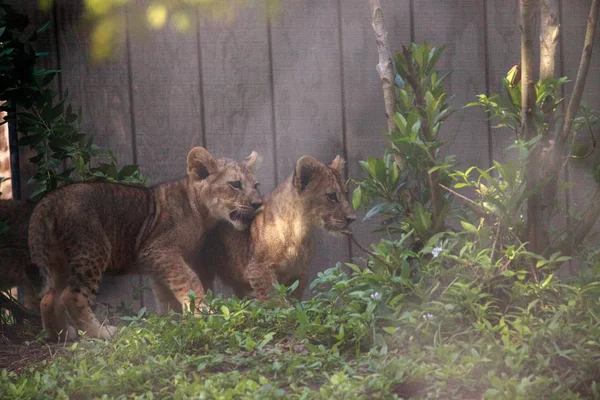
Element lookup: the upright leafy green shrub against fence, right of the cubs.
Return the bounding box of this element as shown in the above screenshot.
[352,44,454,241]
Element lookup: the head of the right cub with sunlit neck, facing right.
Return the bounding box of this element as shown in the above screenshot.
[292,156,356,232]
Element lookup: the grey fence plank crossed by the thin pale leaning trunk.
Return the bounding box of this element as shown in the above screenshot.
[340,0,410,257]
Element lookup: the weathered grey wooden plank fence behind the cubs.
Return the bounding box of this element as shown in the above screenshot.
[16,0,600,307]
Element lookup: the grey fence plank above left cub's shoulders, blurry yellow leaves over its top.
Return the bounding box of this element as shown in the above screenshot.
[127,1,203,309]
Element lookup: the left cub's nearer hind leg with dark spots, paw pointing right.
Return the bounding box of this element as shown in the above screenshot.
[60,231,117,339]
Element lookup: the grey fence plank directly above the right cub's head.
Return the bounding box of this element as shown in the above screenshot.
[271,0,349,288]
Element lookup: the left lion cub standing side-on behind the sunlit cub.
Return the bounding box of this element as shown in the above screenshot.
[29,147,262,339]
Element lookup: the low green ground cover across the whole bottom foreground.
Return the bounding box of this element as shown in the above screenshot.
[0,278,600,400]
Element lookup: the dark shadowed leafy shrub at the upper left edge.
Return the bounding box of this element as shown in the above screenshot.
[0,5,145,200]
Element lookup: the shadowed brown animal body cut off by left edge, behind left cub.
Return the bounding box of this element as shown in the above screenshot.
[0,200,40,310]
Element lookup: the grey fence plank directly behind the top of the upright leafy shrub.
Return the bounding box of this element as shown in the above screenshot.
[414,0,489,167]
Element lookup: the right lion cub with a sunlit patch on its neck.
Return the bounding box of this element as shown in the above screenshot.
[191,156,356,301]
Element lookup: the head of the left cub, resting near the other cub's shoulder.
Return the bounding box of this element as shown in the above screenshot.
[187,147,262,230]
